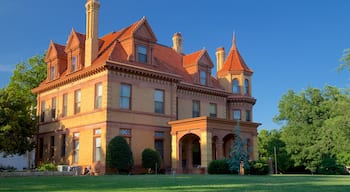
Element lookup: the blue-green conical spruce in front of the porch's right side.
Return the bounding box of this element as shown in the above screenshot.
[228,121,249,173]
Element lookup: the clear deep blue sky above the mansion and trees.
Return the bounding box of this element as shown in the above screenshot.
[0,0,350,130]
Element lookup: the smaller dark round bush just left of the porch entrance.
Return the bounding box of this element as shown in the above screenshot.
[142,148,162,171]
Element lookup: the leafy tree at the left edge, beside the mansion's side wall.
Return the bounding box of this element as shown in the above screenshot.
[0,55,46,155]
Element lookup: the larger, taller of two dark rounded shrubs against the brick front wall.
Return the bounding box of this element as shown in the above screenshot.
[106,136,134,173]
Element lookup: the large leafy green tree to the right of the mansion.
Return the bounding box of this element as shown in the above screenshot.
[275,86,350,172]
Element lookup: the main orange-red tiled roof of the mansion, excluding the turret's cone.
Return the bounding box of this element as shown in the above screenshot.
[35,17,224,91]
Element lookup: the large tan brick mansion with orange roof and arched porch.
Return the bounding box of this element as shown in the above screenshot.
[32,0,260,174]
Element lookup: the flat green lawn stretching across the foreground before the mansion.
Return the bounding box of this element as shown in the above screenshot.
[0,175,350,192]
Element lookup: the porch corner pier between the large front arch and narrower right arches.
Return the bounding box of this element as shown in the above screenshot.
[200,131,212,168]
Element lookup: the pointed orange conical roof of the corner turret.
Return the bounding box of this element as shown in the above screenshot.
[217,36,253,75]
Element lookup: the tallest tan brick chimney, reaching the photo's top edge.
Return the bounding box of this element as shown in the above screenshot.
[85,0,100,67]
